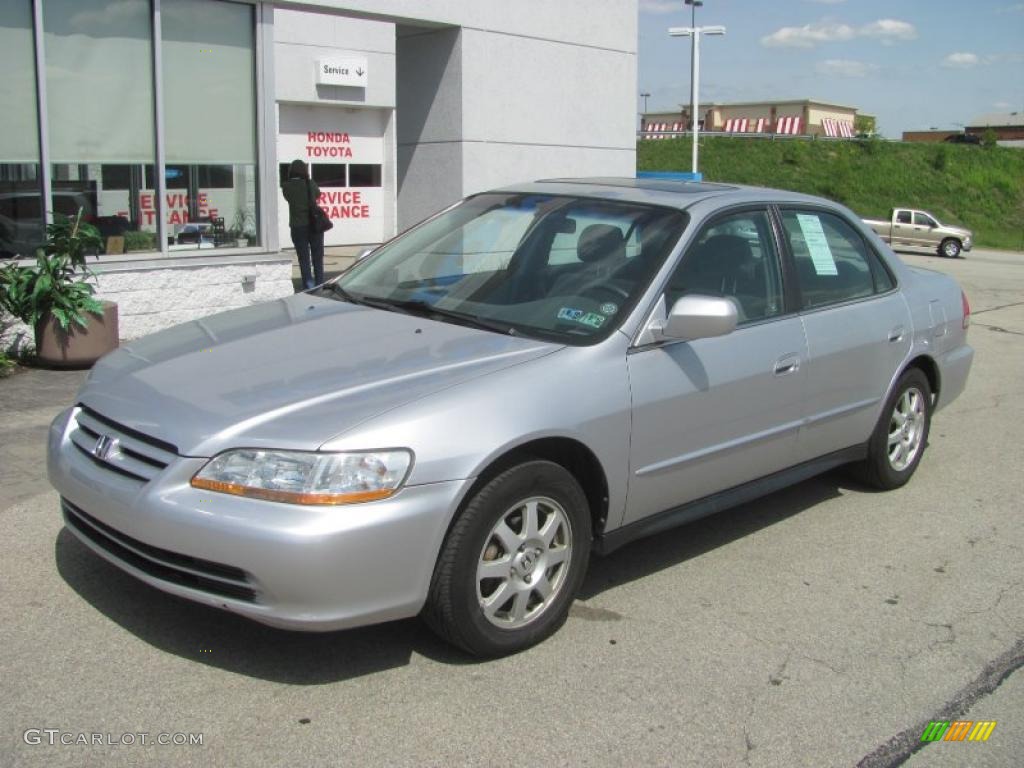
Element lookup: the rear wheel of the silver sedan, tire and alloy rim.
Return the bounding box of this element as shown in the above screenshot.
[857,368,932,490]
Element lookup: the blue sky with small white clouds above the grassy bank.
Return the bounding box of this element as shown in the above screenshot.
[637,0,1024,138]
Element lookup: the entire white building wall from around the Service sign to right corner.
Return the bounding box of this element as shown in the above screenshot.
[274,0,637,230]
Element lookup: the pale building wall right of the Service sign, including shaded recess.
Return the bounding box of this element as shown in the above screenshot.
[387,0,637,229]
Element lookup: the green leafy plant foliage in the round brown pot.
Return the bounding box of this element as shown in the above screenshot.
[0,210,102,332]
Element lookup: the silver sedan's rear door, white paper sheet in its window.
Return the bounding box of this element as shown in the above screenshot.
[781,210,912,461]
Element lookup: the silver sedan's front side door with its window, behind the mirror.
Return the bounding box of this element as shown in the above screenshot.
[624,211,806,523]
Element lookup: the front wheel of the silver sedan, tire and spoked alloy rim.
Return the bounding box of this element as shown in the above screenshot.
[423,461,591,656]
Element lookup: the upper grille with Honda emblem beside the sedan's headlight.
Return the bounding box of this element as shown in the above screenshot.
[69,406,178,482]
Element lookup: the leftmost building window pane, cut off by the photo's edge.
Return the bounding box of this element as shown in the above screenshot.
[0,0,44,258]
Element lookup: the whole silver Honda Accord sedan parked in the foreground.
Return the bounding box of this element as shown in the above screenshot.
[48,178,974,655]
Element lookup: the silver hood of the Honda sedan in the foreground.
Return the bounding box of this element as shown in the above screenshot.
[78,294,560,457]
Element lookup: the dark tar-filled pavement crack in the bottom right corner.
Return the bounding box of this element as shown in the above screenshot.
[857,638,1024,768]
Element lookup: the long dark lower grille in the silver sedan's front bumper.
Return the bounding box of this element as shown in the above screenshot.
[60,499,257,602]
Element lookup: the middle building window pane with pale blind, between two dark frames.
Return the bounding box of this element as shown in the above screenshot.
[43,0,157,252]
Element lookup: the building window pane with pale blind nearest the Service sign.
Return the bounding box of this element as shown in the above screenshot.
[161,0,259,250]
